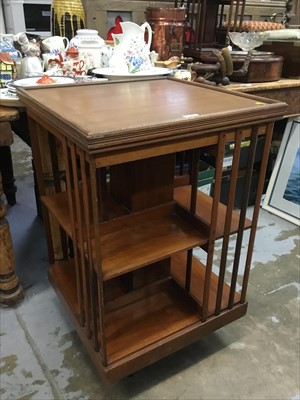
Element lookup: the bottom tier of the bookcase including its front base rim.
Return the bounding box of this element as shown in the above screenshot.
[49,255,247,381]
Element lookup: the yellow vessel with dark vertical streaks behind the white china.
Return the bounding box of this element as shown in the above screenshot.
[51,0,85,40]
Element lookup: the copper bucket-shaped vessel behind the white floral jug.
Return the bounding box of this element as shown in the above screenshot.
[146,7,186,61]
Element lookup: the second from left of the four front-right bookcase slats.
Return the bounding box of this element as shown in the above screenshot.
[215,130,242,315]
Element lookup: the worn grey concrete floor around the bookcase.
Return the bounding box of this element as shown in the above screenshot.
[0,137,300,400]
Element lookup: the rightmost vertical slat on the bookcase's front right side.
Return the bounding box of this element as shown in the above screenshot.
[240,123,274,303]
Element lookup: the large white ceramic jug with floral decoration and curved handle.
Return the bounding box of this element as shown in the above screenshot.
[109,21,152,73]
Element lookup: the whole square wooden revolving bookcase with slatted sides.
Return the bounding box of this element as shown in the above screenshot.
[19,78,286,381]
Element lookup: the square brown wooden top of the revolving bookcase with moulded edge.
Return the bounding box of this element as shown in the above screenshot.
[18,78,286,153]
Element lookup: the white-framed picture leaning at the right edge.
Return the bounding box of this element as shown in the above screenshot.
[262,116,300,226]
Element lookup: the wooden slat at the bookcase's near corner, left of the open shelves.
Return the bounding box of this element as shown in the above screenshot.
[89,159,107,365]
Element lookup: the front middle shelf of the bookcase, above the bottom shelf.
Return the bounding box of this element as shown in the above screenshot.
[96,203,208,281]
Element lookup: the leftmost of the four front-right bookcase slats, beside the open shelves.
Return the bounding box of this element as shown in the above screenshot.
[202,133,225,321]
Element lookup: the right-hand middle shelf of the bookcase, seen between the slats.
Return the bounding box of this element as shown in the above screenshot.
[174,185,252,239]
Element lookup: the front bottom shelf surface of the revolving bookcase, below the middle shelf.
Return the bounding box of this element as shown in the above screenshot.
[105,281,201,363]
